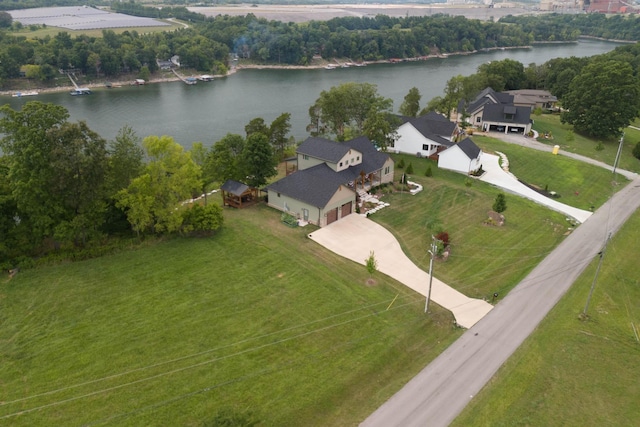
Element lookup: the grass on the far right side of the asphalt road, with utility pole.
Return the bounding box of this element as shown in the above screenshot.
[453,212,640,426]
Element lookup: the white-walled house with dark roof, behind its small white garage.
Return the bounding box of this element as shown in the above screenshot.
[389,112,458,157]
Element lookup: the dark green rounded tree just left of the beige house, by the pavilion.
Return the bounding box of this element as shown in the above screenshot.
[241,133,278,187]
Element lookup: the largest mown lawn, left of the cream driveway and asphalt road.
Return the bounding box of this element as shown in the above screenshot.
[0,205,460,426]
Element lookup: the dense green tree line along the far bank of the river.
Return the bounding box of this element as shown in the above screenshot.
[0,10,640,83]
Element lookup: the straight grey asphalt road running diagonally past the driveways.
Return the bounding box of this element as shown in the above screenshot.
[361,177,640,427]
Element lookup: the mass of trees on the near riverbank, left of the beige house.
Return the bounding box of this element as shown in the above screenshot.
[0,102,290,270]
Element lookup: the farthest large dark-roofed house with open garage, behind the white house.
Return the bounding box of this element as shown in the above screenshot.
[458,87,531,135]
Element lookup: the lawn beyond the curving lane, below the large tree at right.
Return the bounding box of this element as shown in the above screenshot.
[532,114,640,173]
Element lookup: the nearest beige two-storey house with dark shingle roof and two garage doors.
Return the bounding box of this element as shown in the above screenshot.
[265,136,394,227]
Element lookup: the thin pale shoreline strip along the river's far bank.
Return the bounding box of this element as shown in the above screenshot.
[0,46,532,96]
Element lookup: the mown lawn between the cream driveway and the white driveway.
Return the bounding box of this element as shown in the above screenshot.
[371,155,570,299]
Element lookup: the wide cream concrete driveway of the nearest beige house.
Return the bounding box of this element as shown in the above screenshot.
[309,214,493,328]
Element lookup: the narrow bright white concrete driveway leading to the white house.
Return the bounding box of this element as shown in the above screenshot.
[480,153,592,223]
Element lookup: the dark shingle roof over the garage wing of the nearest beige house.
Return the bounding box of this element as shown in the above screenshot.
[265,163,356,208]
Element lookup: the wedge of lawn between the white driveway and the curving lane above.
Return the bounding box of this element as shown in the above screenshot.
[473,136,627,210]
